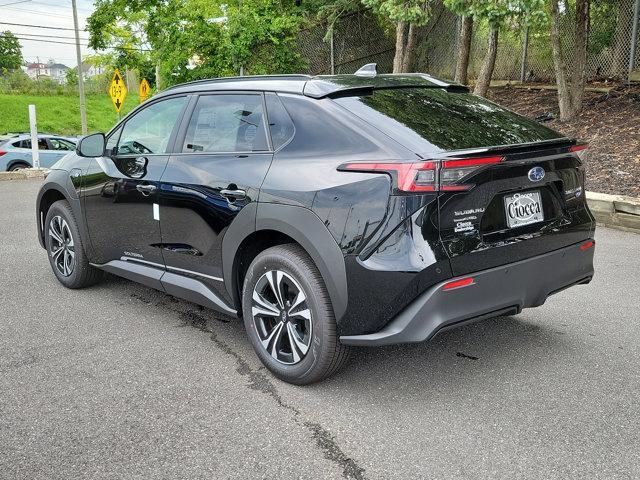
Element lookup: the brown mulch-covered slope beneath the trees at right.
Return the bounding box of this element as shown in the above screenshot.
[490,86,640,197]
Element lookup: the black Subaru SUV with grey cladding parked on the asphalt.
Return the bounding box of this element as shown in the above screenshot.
[37,70,595,384]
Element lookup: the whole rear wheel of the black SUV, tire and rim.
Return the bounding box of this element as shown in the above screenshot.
[242,244,349,385]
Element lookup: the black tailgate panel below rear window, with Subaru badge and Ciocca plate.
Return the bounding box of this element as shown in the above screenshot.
[438,142,594,276]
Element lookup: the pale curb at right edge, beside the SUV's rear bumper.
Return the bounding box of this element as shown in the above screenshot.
[587,192,640,233]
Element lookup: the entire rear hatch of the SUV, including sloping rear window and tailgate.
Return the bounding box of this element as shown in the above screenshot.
[335,87,594,276]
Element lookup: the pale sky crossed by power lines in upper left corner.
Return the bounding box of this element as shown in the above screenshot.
[0,0,94,67]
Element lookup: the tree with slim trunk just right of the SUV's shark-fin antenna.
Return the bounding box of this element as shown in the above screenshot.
[362,0,433,73]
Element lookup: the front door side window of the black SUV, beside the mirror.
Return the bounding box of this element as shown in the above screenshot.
[116,97,186,155]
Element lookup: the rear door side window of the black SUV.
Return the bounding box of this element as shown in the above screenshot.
[182,94,269,153]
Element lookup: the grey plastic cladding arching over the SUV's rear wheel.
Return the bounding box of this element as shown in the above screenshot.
[222,203,348,321]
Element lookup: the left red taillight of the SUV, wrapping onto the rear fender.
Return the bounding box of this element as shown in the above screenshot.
[338,156,504,192]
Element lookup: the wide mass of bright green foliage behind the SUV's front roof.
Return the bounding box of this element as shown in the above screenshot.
[87,0,304,85]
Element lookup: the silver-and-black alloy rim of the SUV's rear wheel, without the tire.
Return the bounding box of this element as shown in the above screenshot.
[251,270,313,365]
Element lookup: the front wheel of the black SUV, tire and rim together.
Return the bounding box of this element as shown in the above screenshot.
[44,200,102,288]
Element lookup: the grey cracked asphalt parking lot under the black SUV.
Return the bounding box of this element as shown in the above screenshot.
[0,181,640,479]
